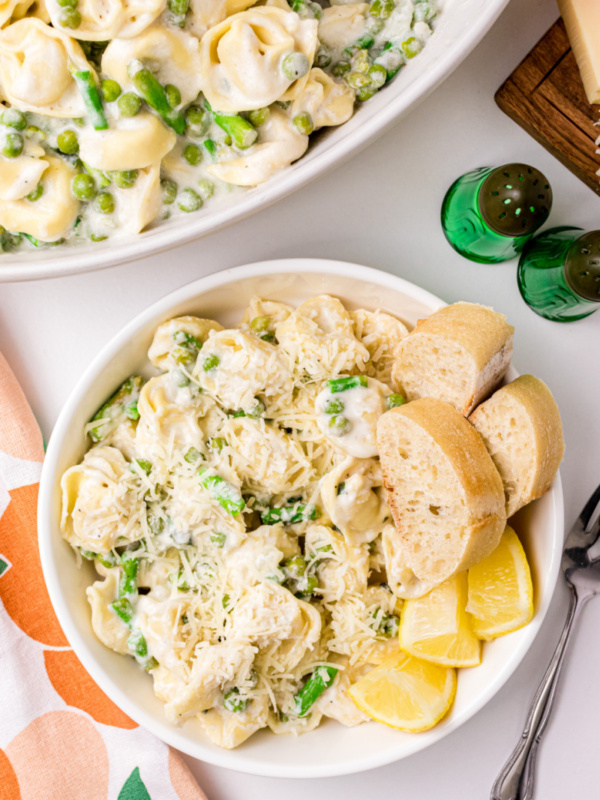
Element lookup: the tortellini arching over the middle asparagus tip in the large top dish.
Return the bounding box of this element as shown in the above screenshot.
[102,25,202,106]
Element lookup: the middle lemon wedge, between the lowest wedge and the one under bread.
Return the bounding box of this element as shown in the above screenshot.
[400,572,481,667]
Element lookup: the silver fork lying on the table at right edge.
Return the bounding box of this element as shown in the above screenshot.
[490,486,600,800]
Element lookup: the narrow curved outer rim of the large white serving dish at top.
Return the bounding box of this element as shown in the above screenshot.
[0,0,510,283]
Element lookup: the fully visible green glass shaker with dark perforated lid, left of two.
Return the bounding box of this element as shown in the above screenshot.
[442,164,552,264]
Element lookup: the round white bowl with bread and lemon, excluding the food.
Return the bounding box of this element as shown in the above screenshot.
[38,259,563,778]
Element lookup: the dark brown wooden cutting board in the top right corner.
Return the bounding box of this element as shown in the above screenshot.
[496,18,600,194]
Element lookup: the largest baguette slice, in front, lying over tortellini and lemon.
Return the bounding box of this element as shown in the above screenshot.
[377,398,506,597]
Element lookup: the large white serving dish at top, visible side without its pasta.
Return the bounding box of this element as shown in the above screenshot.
[0,0,509,283]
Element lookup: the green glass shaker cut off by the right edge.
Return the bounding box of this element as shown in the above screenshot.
[517,226,600,322]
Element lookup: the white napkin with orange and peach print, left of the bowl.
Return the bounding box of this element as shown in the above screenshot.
[0,354,206,800]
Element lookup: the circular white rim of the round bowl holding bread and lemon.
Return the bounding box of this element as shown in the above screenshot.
[37,258,564,778]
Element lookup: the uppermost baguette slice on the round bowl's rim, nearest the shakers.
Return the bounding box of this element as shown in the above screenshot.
[392,303,514,416]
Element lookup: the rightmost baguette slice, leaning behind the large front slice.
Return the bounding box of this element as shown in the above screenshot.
[469,375,565,517]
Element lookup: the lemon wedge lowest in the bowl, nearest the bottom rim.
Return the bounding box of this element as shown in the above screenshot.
[348,651,456,733]
